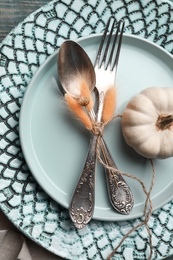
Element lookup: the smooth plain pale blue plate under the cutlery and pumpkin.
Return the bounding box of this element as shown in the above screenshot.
[20,35,173,221]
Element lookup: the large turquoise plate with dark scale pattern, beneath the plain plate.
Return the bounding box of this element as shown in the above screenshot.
[0,0,173,260]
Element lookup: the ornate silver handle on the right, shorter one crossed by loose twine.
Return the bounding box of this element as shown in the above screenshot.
[100,138,134,215]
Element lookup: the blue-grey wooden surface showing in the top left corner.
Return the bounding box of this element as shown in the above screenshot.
[0,0,50,42]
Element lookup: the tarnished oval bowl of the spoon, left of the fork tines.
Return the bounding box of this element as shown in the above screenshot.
[58,40,96,97]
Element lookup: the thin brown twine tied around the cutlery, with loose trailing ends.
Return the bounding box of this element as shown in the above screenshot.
[92,115,156,260]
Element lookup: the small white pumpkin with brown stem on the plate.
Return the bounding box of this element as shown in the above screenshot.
[122,87,173,159]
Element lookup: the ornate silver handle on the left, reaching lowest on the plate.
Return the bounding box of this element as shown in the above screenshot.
[69,135,97,228]
